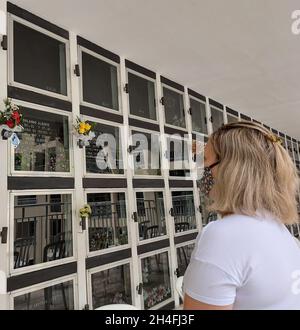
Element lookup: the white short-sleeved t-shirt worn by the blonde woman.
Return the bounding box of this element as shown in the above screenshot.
[183,215,300,309]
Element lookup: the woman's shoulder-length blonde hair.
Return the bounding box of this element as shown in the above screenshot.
[209,121,299,224]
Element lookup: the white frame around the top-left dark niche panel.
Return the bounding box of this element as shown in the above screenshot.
[8,13,71,101]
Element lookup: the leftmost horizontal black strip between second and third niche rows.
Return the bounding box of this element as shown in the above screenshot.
[7,176,74,190]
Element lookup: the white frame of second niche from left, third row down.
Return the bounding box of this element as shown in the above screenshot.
[84,188,132,258]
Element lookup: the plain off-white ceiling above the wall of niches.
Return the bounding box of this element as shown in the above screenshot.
[11,0,300,140]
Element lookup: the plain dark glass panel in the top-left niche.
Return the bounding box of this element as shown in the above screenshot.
[13,21,67,95]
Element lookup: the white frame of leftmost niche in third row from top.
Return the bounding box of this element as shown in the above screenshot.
[7,189,78,275]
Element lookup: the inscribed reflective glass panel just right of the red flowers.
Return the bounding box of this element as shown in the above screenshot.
[14,108,70,172]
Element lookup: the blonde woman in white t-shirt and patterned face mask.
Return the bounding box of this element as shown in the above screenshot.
[183,121,300,309]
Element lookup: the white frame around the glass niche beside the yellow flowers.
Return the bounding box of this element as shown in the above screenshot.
[81,115,127,178]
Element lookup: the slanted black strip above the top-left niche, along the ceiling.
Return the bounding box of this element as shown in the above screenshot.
[7,2,69,40]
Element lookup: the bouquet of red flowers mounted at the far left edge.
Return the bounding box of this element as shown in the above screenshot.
[0,99,23,140]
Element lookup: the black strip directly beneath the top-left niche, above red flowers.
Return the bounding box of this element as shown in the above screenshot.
[7,86,72,112]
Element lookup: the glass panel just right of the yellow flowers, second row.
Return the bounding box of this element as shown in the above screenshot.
[85,123,124,174]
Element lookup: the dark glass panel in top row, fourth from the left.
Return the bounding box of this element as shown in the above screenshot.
[163,87,185,128]
